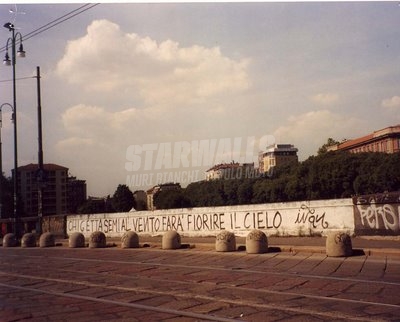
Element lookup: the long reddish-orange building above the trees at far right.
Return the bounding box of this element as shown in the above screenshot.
[328,124,400,153]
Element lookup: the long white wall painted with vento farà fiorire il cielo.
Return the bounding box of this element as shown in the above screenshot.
[66,199,355,237]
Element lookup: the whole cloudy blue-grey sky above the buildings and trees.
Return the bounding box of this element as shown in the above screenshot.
[0,1,400,196]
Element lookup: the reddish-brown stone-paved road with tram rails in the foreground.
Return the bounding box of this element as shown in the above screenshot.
[0,245,400,322]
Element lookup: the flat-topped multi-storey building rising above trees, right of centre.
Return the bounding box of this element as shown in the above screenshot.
[258,144,298,173]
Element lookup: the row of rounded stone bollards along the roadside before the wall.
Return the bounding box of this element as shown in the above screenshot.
[3,229,353,257]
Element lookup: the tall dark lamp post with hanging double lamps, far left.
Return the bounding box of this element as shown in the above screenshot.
[3,22,25,237]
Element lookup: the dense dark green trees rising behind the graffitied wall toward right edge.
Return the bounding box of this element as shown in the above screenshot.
[154,151,400,209]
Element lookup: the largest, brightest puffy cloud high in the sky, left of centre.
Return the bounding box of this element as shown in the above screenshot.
[57,20,250,104]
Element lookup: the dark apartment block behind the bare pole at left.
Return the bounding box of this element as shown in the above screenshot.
[17,163,68,217]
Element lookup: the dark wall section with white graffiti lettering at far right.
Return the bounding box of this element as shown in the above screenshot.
[353,192,400,235]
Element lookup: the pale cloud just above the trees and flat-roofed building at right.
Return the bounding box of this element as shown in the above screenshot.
[274,110,364,160]
